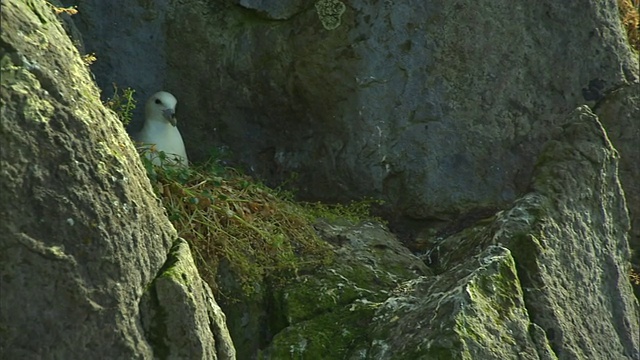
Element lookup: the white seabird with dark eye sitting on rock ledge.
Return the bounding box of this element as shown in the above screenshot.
[138,91,189,166]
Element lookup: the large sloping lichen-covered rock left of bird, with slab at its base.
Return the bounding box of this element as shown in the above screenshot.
[0,0,233,359]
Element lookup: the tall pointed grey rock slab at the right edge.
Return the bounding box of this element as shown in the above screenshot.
[434,107,640,359]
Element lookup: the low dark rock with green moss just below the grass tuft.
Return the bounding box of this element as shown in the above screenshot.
[242,221,430,359]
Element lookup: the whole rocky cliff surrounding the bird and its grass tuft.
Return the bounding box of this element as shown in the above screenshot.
[0,0,640,360]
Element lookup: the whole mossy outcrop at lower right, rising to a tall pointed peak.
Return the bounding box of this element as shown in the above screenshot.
[262,107,640,360]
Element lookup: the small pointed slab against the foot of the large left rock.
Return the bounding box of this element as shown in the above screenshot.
[141,240,235,359]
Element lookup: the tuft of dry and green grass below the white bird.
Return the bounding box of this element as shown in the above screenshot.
[142,154,333,296]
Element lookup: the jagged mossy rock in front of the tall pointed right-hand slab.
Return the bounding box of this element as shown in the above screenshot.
[367,245,550,360]
